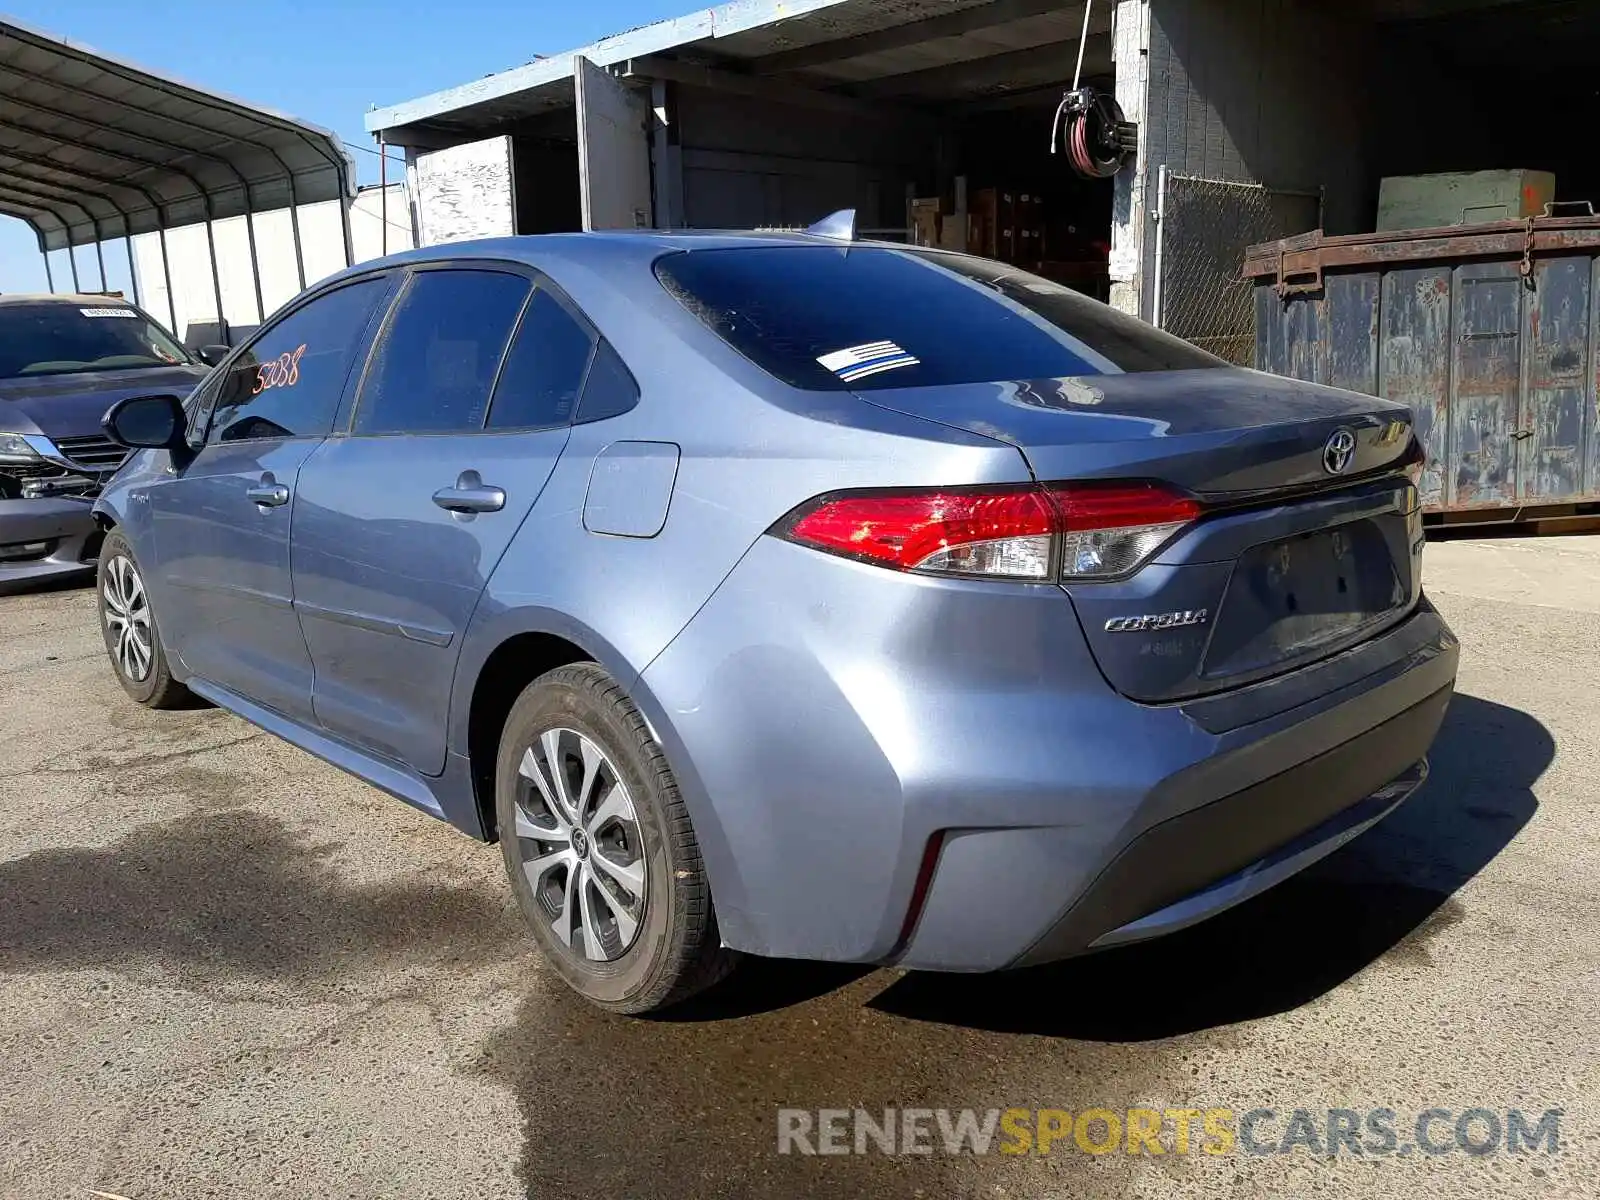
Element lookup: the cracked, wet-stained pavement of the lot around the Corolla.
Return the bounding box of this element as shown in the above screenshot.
[0,538,1600,1200]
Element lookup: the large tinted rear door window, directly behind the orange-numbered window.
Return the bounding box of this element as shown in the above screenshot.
[352,270,531,434]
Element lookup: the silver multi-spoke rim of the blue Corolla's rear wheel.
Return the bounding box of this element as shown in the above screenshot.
[515,728,648,962]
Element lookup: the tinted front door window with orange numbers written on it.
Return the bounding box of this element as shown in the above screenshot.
[208,278,389,442]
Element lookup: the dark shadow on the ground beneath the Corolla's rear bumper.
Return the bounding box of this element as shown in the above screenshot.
[872,694,1555,1042]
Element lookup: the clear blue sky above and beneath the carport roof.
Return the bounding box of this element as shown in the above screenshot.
[0,0,681,291]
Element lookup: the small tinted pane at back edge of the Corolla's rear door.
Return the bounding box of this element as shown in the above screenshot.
[490,288,594,429]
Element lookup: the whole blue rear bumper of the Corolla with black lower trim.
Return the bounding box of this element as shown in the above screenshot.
[640,539,1458,971]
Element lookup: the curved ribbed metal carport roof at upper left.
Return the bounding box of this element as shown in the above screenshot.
[0,21,355,253]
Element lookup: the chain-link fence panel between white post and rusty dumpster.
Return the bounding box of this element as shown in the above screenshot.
[1154,168,1322,366]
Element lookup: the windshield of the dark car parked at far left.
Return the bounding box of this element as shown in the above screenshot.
[0,301,190,378]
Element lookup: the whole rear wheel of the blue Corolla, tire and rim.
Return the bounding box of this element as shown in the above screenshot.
[494,662,736,1014]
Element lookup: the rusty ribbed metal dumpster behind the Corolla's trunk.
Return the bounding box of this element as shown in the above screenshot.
[1245,214,1600,520]
